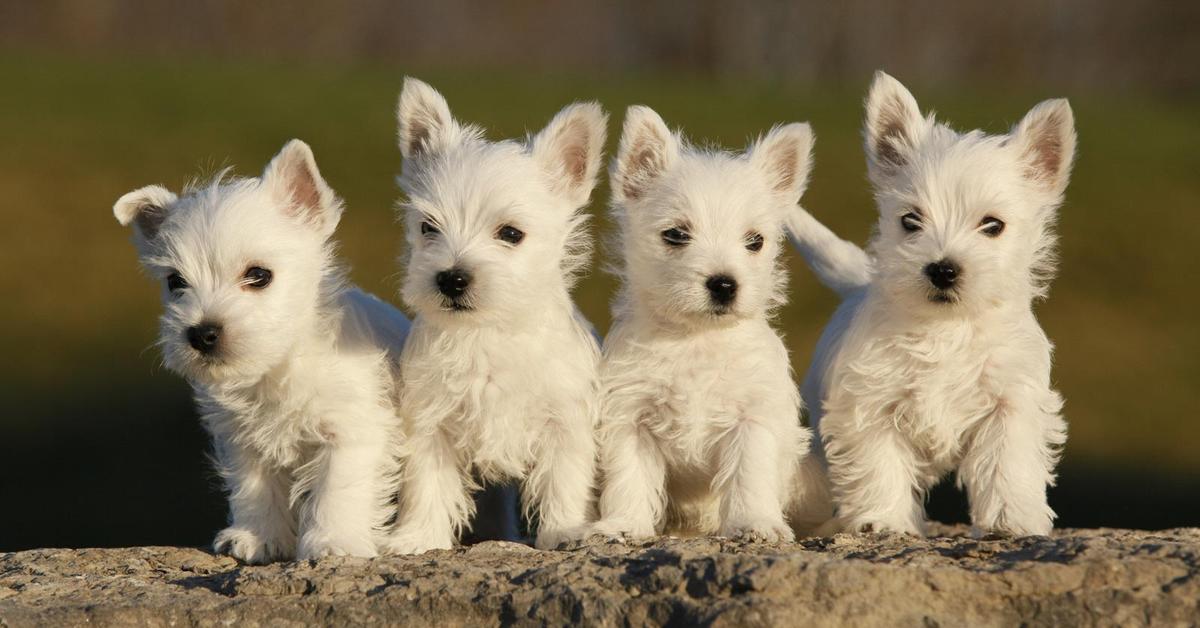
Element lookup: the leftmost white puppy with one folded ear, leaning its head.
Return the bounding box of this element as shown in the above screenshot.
[113,139,409,563]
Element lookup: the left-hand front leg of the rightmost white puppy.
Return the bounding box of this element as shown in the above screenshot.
[821,422,925,536]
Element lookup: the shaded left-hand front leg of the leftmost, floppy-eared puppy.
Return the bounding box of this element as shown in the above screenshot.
[212,436,296,564]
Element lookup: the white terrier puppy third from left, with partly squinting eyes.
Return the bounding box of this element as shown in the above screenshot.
[594,107,812,540]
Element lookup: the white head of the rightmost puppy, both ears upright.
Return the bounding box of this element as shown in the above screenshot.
[864,72,1075,313]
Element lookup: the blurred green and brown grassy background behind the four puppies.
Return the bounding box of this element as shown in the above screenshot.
[0,1,1200,550]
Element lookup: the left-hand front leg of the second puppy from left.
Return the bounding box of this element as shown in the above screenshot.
[385,430,474,554]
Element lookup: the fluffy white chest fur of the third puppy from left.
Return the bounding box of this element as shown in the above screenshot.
[602,323,799,474]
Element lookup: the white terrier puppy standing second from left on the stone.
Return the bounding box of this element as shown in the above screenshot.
[388,79,606,554]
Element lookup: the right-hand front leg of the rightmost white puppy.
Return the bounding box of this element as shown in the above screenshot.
[959,389,1067,536]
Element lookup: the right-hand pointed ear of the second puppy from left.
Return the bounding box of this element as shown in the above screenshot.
[532,102,608,207]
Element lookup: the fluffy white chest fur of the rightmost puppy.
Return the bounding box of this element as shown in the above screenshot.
[826,321,1003,469]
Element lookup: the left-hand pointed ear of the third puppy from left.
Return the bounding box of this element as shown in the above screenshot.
[611,104,679,202]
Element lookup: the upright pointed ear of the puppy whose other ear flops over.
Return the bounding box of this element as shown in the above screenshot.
[263,139,342,238]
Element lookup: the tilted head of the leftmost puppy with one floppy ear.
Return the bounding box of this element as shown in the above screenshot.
[113,139,342,383]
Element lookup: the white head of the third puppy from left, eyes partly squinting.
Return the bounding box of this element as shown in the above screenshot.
[611,107,812,325]
